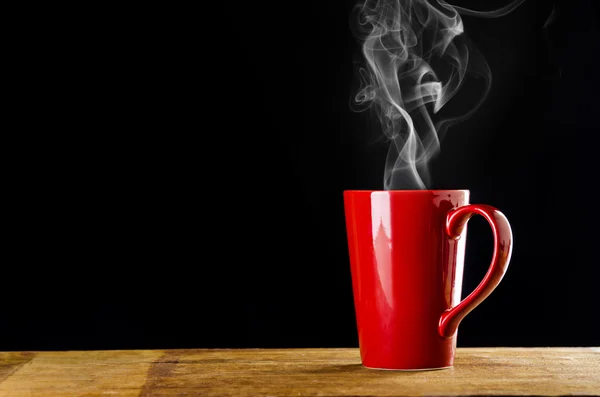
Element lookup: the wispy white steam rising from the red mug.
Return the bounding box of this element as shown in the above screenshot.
[355,0,524,190]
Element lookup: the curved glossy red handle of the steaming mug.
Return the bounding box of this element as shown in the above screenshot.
[438,204,513,339]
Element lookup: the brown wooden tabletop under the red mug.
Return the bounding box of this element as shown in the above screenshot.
[0,348,600,397]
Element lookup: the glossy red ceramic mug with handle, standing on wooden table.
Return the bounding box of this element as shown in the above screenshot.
[344,190,513,370]
